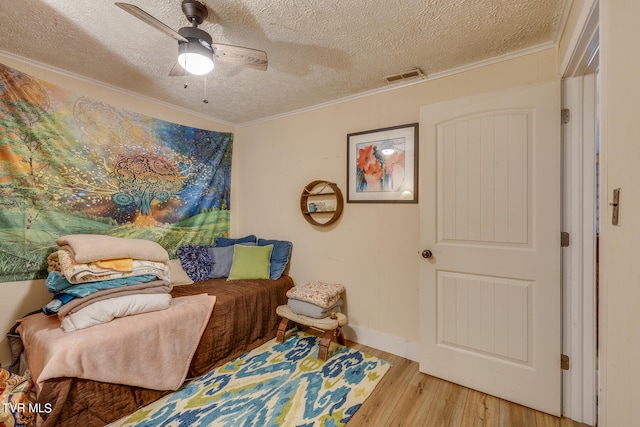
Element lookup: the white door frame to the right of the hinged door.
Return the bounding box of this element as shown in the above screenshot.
[561,0,606,425]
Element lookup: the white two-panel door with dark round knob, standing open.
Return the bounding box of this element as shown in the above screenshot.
[420,80,562,415]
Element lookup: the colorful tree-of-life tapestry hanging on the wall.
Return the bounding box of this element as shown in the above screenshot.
[0,64,233,282]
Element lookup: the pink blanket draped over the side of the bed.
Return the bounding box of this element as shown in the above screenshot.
[19,294,216,391]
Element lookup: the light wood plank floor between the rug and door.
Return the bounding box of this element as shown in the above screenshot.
[347,343,587,427]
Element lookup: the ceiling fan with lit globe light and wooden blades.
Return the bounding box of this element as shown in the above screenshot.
[115,0,268,76]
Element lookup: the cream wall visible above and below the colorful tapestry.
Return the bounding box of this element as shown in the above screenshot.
[0,52,235,365]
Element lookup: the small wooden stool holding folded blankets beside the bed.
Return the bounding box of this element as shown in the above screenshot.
[276,305,347,360]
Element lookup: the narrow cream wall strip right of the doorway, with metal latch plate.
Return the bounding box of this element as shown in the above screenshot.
[598,0,640,427]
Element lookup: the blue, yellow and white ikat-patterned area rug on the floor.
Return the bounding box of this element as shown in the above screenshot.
[111,331,391,427]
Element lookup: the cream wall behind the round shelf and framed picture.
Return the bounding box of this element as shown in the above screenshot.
[232,49,558,359]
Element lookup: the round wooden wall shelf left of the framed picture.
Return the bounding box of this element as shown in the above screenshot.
[300,180,344,227]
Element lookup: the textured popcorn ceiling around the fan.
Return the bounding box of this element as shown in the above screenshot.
[0,0,570,124]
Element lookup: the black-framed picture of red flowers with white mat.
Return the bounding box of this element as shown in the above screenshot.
[347,123,418,203]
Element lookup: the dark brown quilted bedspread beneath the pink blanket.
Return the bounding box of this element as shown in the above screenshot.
[38,276,293,427]
